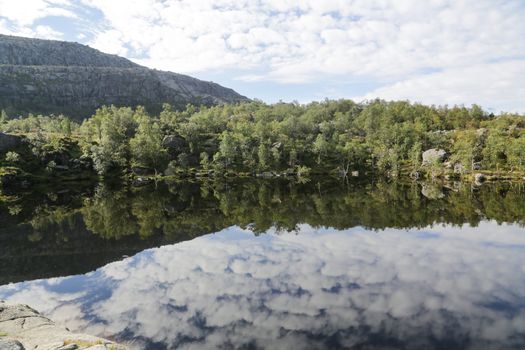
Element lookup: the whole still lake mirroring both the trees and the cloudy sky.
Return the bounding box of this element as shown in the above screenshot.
[0,179,525,349]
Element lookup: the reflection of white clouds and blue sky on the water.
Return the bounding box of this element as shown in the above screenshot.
[0,221,525,349]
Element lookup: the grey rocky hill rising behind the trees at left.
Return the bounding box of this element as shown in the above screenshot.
[0,35,247,119]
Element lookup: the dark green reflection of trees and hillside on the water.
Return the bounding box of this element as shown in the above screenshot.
[0,179,525,284]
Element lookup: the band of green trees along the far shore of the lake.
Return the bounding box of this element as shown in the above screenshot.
[0,100,525,176]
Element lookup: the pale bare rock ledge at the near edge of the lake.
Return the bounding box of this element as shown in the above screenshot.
[0,301,127,350]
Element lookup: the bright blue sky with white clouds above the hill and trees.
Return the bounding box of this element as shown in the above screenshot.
[0,0,525,113]
